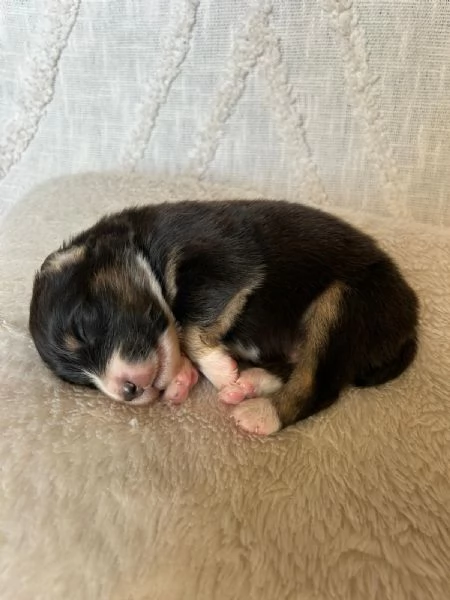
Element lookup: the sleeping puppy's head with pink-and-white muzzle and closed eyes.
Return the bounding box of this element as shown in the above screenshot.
[29,232,180,404]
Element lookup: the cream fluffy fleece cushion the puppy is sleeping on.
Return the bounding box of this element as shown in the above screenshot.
[0,175,450,600]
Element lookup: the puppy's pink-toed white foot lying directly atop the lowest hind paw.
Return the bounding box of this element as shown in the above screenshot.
[219,367,283,404]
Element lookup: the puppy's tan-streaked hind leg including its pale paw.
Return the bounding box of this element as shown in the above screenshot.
[232,283,345,435]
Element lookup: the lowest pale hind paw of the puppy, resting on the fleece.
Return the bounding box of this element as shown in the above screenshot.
[231,398,281,435]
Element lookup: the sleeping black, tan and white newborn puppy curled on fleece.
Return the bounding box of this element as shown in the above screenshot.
[30,200,418,434]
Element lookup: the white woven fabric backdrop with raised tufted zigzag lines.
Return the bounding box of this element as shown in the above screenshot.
[0,0,450,226]
